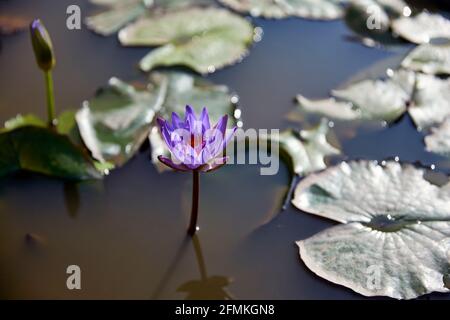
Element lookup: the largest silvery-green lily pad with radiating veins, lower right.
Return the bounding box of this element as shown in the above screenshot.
[292,161,450,299]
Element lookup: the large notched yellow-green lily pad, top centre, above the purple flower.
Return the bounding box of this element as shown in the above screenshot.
[119,7,254,74]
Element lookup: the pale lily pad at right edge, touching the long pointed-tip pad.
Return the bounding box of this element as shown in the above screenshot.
[409,74,450,129]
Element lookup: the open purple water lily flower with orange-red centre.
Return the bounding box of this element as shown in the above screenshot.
[157,106,236,172]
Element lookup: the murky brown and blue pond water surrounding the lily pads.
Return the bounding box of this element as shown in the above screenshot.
[0,0,450,299]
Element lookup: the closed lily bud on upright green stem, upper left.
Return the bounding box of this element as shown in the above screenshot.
[30,19,56,71]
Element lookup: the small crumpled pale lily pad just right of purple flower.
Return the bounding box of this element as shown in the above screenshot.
[260,119,340,176]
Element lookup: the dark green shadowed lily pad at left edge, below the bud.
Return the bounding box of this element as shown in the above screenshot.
[0,126,102,180]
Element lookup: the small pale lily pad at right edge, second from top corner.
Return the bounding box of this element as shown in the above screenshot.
[402,41,450,75]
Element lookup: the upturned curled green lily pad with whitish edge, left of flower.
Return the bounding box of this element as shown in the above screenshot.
[76,78,167,166]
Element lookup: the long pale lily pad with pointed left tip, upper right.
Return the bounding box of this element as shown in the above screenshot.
[297,70,415,122]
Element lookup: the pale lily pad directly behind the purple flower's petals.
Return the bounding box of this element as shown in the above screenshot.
[149,72,237,172]
